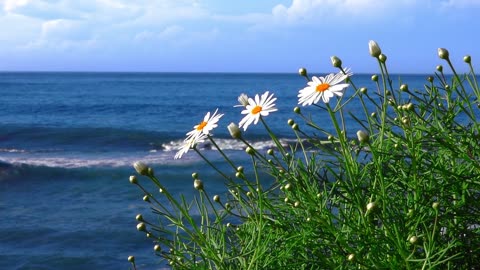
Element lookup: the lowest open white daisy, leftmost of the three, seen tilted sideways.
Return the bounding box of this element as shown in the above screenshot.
[175,109,223,159]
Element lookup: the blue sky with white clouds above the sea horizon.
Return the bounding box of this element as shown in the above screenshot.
[0,0,480,73]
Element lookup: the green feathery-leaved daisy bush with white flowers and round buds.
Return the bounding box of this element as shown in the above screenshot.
[129,41,480,269]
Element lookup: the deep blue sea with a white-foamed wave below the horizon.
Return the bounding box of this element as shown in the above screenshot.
[0,71,464,269]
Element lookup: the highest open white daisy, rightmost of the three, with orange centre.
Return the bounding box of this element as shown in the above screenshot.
[298,69,352,106]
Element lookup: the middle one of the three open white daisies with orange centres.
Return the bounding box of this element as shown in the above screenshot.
[238,91,277,130]
